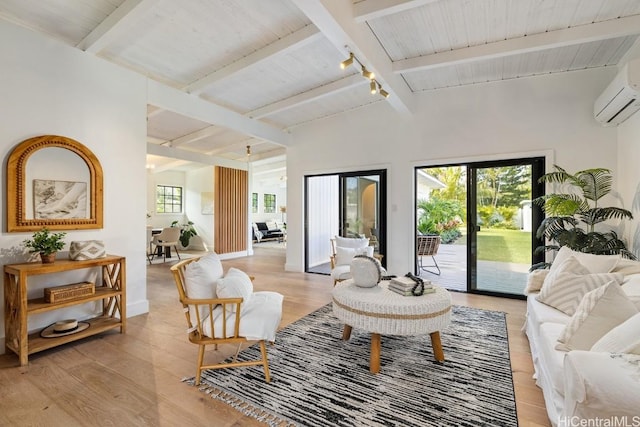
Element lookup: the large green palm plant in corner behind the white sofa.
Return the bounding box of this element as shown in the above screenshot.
[532,165,636,268]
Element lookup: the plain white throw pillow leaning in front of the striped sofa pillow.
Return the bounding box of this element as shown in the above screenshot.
[556,282,638,351]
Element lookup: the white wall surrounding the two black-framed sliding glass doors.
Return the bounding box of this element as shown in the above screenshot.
[286,69,620,273]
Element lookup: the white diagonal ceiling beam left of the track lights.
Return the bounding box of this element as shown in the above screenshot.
[183,25,322,94]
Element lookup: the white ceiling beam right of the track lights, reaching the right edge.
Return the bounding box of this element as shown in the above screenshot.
[393,15,640,74]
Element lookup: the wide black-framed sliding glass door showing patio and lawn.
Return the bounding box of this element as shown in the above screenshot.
[416,158,544,297]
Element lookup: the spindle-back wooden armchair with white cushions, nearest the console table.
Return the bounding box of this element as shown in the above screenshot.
[170,253,283,385]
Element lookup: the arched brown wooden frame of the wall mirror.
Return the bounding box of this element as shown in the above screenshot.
[6,135,103,232]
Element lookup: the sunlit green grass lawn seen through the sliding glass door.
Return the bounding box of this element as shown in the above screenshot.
[455,228,531,264]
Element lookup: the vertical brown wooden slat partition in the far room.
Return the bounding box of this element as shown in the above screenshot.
[213,166,249,254]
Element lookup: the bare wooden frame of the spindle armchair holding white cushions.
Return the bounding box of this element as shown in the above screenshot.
[170,257,271,385]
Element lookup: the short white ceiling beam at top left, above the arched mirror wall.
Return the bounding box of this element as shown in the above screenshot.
[76,0,158,53]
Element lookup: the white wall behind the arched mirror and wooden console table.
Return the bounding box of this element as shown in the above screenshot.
[0,20,149,351]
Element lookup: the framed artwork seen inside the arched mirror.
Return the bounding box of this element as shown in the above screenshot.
[33,179,88,219]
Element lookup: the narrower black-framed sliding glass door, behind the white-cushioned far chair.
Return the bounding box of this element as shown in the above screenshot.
[305,170,386,274]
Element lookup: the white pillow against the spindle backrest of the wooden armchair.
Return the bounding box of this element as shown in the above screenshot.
[184,252,223,322]
